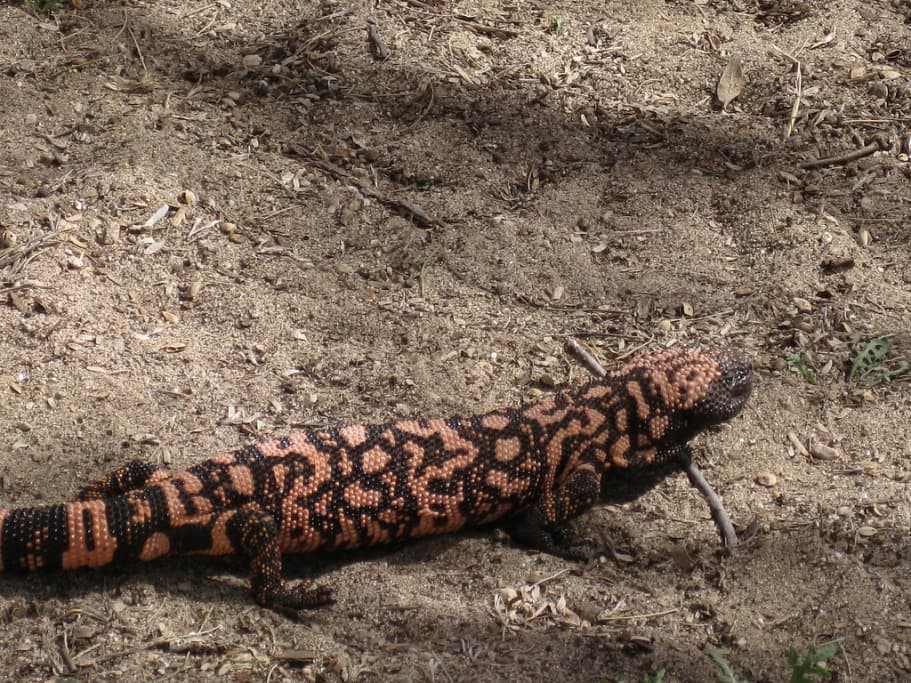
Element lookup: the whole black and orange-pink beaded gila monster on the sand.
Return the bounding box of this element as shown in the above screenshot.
[0,348,752,611]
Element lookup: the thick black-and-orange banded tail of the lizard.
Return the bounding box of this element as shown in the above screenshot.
[0,496,169,571]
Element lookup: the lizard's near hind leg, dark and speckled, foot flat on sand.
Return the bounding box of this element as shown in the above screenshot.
[224,503,334,616]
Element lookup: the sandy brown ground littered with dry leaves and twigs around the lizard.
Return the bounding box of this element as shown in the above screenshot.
[0,0,911,682]
